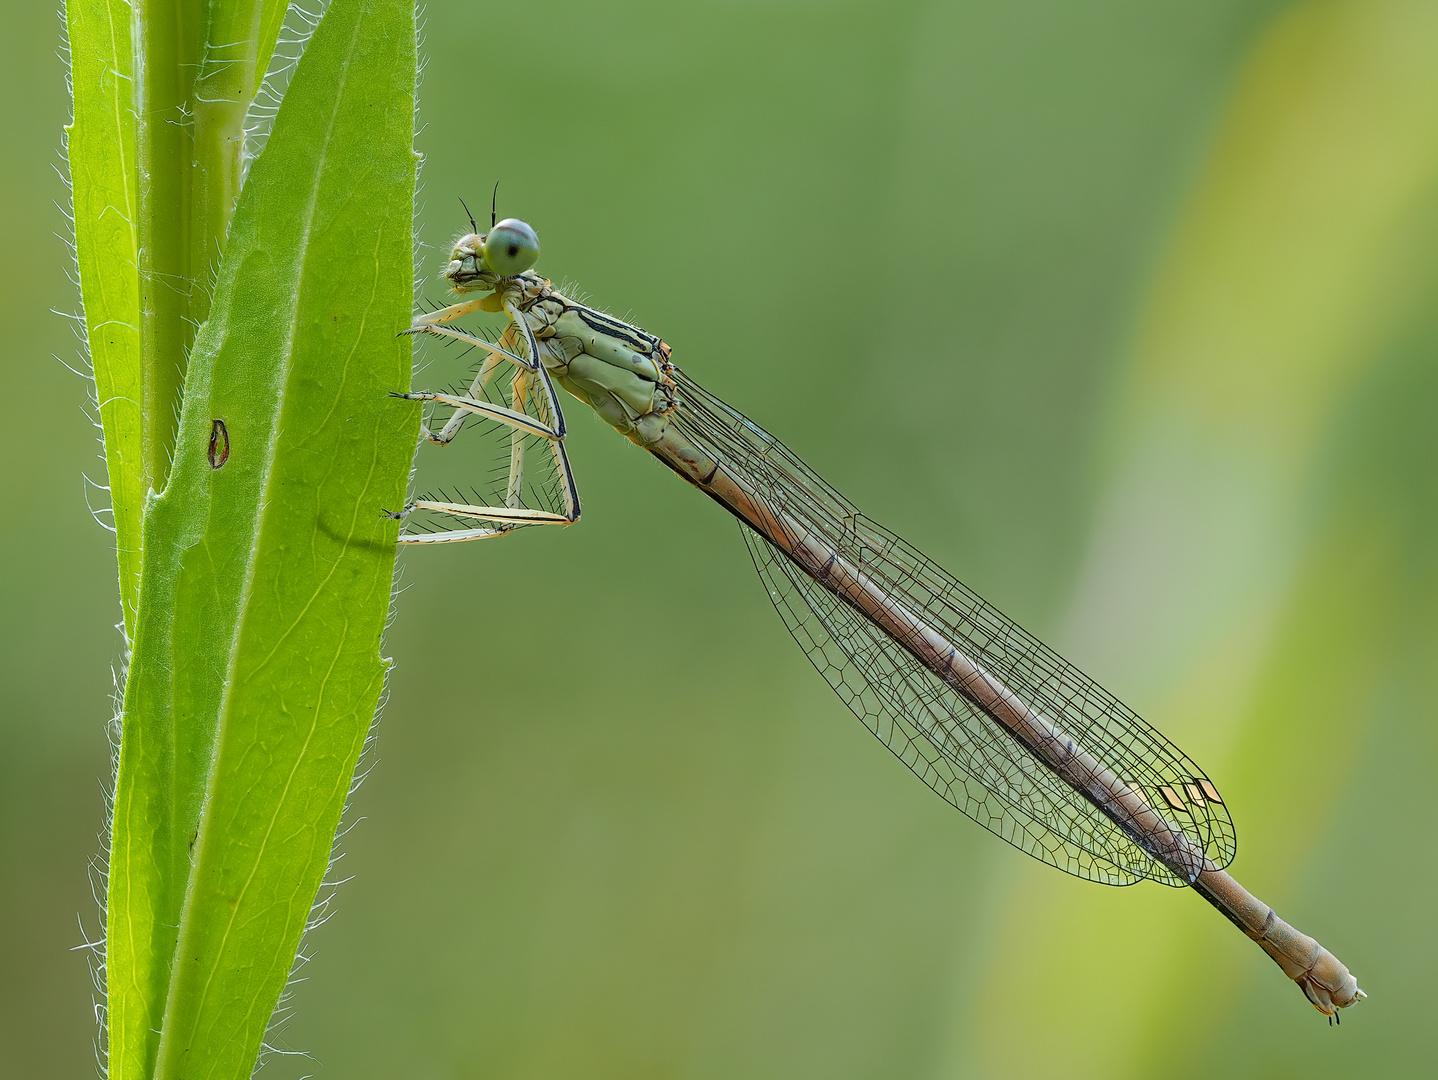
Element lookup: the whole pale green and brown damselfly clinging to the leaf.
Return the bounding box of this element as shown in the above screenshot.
[394,211,1365,1022]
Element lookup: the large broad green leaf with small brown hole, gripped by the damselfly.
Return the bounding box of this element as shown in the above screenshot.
[106,0,417,1080]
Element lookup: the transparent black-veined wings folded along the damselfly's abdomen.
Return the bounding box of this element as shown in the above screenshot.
[674,370,1237,886]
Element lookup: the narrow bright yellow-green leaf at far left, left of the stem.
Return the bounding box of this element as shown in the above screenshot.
[65,0,150,633]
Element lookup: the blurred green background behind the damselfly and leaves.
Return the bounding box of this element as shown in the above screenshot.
[0,0,1438,1080]
